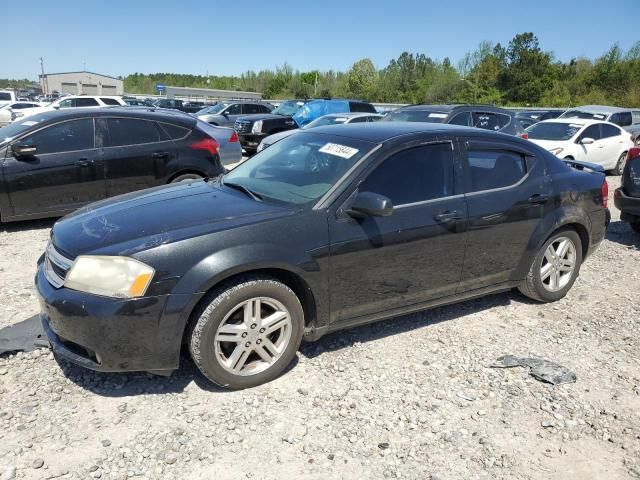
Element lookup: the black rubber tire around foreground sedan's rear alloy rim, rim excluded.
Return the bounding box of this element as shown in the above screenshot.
[518,228,582,303]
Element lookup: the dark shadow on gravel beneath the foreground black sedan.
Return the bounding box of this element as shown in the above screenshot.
[56,292,524,398]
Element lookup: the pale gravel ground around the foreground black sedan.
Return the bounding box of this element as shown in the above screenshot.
[0,177,640,480]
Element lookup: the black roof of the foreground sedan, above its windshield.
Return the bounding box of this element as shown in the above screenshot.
[309,122,512,143]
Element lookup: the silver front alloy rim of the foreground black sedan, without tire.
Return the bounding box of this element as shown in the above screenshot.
[214,297,292,376]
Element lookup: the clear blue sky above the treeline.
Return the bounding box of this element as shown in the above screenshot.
[0,0,640,79]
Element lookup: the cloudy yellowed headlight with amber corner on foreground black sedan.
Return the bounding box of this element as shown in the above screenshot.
[64,256,155,298]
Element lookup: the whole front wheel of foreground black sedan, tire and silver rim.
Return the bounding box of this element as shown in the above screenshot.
[189,277,304,389]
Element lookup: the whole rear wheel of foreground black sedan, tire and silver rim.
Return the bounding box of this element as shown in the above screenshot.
[518,229,582,302]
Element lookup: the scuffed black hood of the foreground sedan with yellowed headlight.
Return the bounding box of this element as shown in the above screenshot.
[52,180,294,258]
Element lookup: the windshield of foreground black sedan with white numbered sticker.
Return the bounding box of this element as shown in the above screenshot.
[222,132,374,205]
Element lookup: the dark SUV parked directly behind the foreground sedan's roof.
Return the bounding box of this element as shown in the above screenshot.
[382,105,524,135]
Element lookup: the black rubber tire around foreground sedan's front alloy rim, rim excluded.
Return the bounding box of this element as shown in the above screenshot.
[189,276,304,390]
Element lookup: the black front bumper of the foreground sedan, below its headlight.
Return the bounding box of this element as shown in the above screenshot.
[35,262,194,372]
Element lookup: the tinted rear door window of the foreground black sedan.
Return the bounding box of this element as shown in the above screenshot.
[468,150,527,192]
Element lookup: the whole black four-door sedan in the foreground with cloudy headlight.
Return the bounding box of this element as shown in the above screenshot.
[36,122,608,388]
